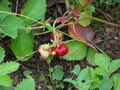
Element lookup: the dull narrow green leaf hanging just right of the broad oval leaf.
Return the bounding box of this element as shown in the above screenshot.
[86,47,97,66]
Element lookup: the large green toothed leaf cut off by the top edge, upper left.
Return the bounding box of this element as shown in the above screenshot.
[21,0,46,24]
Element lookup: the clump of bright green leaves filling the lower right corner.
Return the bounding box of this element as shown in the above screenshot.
[64,53,120,90]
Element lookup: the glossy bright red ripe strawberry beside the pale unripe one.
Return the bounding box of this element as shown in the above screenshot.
[51,43,68,56]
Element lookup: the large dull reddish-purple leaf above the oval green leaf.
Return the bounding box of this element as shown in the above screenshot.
[68,23,95,42]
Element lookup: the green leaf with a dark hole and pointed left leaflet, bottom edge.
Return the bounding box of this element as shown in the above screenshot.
[64,67,99,90]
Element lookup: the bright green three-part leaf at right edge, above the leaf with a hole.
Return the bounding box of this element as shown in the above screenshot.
[94,53,120,75]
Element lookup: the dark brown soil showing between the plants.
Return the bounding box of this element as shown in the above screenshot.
[0,0,120,90]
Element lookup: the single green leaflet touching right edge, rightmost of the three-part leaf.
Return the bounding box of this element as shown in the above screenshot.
[109,59,120,73]
